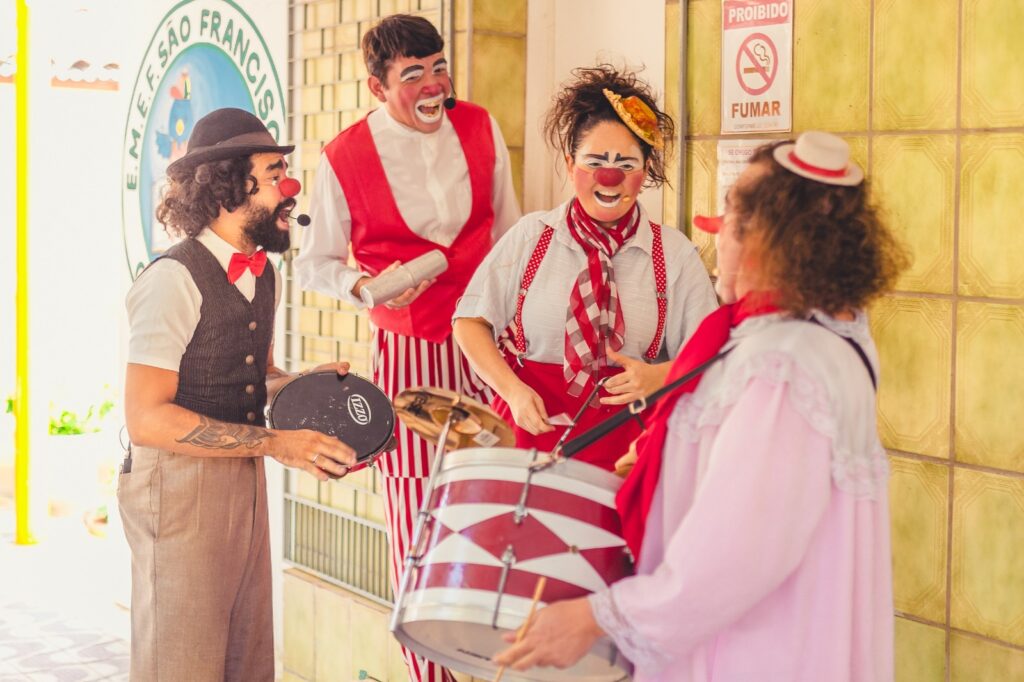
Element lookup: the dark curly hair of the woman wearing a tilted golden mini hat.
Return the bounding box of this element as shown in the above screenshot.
[544,63,676,187]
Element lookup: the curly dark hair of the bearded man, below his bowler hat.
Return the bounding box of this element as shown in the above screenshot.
[157,157,254,237]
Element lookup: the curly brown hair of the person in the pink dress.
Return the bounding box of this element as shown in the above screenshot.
[729,142,907,316]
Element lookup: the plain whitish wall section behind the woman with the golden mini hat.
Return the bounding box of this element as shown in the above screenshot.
[523,0,665,220]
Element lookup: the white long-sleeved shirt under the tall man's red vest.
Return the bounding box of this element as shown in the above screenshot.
[293,109,521,307]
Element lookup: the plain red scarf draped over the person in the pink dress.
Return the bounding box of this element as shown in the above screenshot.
[615,295,779,561]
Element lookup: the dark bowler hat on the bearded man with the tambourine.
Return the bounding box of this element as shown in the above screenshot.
[167,108,295,174]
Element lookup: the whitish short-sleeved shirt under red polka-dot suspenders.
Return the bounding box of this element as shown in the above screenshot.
[454,202,718,365]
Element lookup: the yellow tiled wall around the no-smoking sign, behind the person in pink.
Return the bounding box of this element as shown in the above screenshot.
[666,0,1024,682]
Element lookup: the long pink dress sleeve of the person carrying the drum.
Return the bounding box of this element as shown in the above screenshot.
[590,378,831,670]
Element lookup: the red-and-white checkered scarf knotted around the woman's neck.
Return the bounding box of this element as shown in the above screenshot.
[563,199,640,396]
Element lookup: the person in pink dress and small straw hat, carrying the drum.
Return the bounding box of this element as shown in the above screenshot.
[496,132,904,682]
